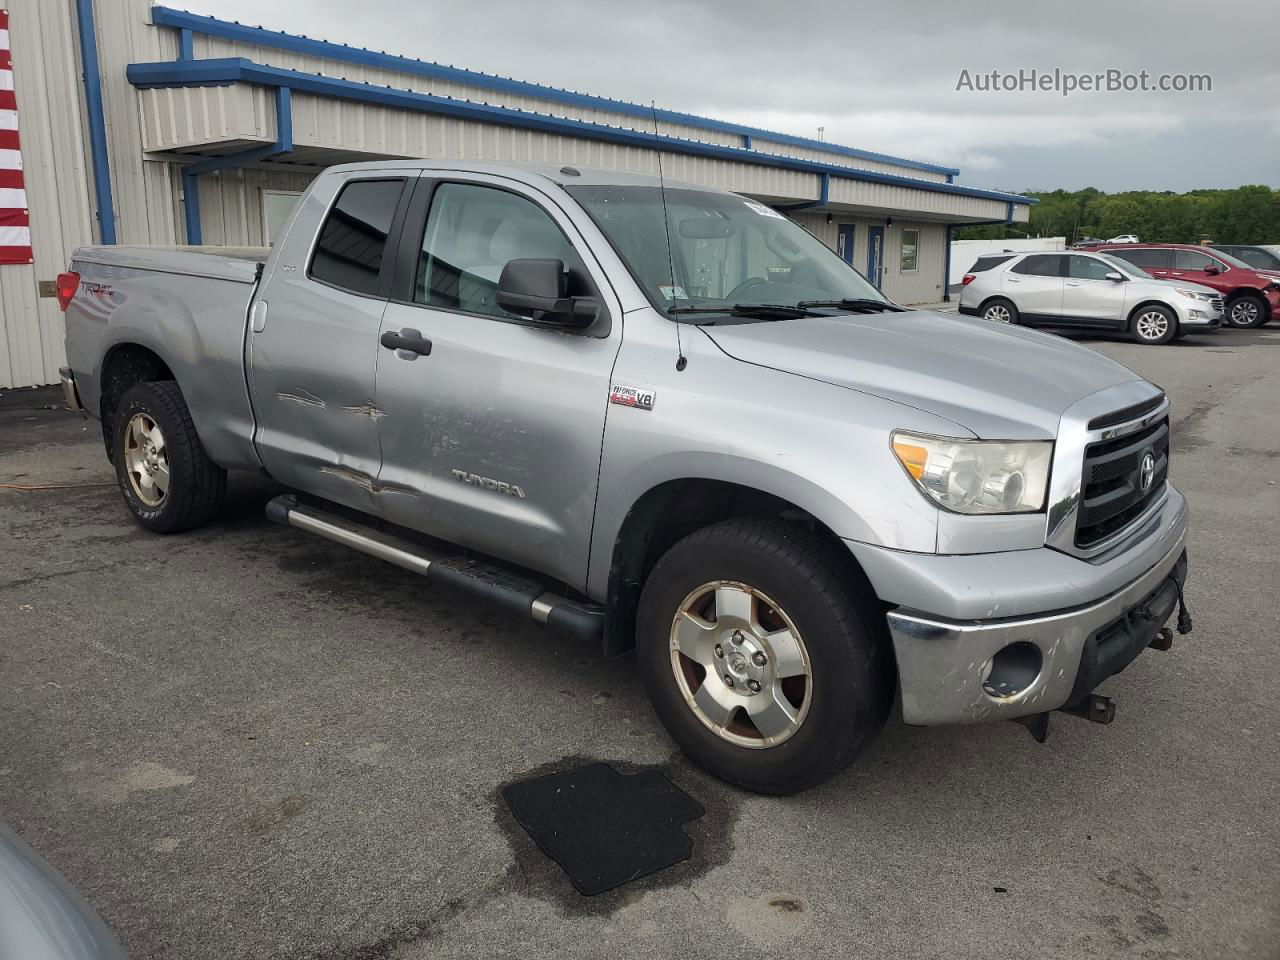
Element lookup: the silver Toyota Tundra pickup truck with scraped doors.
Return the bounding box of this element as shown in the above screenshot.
[59,161,1190,794]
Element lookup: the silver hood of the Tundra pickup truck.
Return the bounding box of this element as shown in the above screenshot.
[701,310,1142,440]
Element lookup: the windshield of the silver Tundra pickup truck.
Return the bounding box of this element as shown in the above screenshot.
[566,186,888,320]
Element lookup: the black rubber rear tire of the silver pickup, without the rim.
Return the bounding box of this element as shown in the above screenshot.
[111,380,227,534]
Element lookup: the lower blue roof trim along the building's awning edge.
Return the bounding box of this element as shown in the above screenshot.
[125,58,1036,204]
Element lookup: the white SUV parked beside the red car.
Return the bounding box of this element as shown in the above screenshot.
[960,252,1222,343]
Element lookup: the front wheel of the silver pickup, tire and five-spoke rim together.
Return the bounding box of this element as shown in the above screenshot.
[636,520,895,794]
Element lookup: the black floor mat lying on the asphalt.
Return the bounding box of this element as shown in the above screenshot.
[502,763,707,896]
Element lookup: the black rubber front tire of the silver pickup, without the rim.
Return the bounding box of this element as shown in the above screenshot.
[636,520,896,794]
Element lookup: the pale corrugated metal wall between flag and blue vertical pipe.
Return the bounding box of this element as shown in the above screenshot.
[0,0,93,388]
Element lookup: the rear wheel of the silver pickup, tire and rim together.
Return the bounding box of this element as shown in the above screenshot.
[113,380,227,534]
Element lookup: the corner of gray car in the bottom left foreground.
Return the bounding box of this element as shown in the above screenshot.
[0,823,125,960]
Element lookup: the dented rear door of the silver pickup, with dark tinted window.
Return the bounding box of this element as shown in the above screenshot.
[247,172,416,511]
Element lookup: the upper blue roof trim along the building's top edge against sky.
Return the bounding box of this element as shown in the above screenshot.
[151,6,960,177]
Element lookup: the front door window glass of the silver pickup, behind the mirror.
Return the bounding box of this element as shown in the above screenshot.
[413,183,582,320]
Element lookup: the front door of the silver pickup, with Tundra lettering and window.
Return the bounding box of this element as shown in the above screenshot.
[378,174,622,586]
